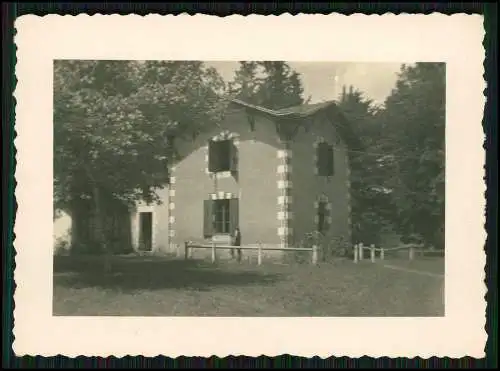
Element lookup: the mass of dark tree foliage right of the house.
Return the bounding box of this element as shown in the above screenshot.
[339,63,446,248]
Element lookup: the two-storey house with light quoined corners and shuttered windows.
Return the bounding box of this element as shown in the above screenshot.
[131,100,353,262]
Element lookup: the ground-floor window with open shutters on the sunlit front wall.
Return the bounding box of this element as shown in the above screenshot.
[203,198,239,238]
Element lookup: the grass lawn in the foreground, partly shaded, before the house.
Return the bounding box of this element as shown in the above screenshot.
[53,257,444,317]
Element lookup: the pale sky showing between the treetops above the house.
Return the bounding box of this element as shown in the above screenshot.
[205,61,401,104]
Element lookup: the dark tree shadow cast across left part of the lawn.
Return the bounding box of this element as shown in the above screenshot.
[54,256,281,291]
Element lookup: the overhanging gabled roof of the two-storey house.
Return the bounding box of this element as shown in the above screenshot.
[230,99,361,148]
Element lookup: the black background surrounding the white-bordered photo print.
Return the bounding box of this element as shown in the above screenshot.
[1,2,498,368]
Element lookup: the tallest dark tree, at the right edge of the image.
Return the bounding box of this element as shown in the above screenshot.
[381,63,446,247]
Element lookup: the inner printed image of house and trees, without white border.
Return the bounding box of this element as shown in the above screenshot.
[53,60,446,317]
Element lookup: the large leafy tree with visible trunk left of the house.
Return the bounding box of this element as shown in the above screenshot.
[54,61,224,251]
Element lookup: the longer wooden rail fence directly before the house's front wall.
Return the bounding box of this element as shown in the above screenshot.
[184,241,318,265]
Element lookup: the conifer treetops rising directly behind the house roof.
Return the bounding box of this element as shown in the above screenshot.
[229,61,304,109]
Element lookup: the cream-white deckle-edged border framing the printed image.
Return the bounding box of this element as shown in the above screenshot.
[13,13,487,358]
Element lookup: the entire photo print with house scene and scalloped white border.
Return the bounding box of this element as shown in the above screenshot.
[13,13,487,358]
